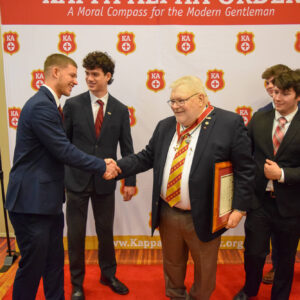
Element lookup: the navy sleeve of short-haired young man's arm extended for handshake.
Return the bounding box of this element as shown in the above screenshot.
[32,102,106,176]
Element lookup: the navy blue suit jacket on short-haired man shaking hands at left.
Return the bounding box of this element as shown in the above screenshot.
[6,86,106,215]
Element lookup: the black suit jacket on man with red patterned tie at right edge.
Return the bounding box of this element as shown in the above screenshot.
[248,109,300,217]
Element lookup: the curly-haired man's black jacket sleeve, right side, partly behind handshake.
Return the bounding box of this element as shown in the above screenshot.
[119,108,136,186]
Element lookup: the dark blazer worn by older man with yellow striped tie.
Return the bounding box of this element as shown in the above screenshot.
[118,108,254,241]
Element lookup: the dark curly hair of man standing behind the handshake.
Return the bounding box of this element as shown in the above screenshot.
[82,51,115,84]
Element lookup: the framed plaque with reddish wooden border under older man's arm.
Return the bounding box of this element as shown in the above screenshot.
[212,161,233,233]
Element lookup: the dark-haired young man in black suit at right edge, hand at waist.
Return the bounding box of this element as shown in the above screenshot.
[234,71,300,300]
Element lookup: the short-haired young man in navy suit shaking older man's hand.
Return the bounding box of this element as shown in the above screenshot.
[6,54,118,300]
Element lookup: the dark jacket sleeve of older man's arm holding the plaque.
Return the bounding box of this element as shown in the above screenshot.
[231,116,255,211]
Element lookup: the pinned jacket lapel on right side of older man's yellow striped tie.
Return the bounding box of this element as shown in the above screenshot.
[190,110,216,174]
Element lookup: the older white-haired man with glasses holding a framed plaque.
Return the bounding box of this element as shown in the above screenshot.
[117,76,254,300]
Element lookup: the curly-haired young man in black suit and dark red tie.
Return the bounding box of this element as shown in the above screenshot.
[64,51,136,300]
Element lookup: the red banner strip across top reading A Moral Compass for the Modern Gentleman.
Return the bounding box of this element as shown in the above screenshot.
[0,0,300,25]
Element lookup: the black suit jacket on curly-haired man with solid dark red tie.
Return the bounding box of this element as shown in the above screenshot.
[63,92,136,194]
